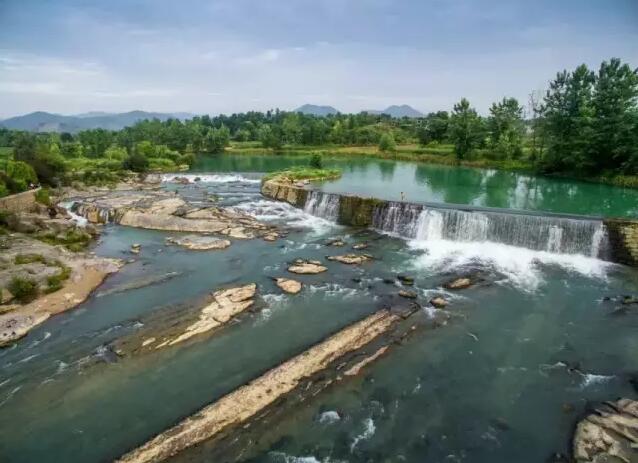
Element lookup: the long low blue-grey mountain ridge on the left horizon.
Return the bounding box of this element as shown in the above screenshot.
[0,111,198,133]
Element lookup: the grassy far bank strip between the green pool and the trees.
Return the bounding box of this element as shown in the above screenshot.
[224,142,638,189]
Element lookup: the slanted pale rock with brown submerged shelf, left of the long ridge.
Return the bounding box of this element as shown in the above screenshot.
[112,283,257,356]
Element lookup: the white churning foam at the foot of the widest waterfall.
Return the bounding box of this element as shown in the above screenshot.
[409,240,614,292]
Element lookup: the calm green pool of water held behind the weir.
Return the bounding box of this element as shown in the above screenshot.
[195,155,638,217]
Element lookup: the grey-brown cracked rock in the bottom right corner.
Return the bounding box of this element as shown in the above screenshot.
[573,399,638,463]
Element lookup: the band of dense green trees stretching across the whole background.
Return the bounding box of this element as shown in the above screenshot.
[0,59,638,196]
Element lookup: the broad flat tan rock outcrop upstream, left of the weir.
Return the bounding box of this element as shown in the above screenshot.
[75,191,276,239]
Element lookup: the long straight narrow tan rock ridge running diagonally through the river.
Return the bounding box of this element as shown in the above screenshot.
[118,310,420,463]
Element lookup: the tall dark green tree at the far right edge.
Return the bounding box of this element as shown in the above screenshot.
[590,58,638,170]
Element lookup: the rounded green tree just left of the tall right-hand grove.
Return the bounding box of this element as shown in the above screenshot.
[487,98,525,159]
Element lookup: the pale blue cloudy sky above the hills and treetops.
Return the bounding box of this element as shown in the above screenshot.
[0,0,638,118]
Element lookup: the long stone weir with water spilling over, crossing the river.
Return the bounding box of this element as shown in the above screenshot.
[262,180,638,265]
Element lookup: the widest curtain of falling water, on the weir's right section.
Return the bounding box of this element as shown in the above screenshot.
[373,202,608,259]
